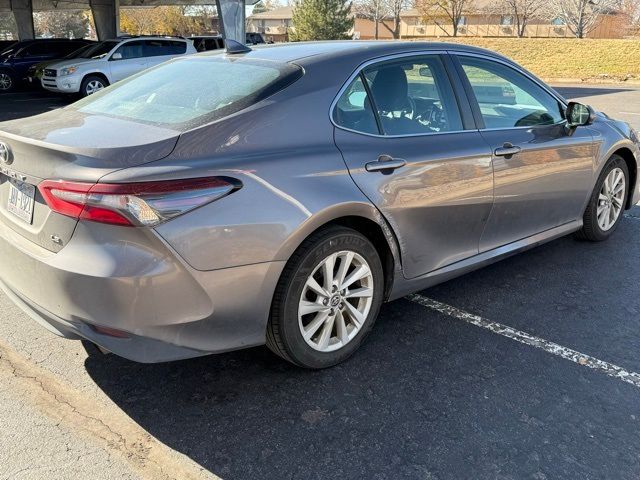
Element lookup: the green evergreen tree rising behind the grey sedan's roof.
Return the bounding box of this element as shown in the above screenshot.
[289,0,354,41]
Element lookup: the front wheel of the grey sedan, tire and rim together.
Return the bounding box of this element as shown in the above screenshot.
[578,155,629,242]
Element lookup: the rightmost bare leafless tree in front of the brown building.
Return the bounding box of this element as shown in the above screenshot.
[546,0,620,38]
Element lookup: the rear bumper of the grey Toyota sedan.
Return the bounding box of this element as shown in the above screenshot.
[0,222,284,363]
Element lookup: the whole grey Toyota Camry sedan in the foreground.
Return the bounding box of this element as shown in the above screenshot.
[0,42,640,368]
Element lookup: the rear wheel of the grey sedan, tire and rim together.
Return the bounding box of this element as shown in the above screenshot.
[267,227,384,369]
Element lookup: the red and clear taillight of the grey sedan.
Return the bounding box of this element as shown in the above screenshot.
[38,177,238,227]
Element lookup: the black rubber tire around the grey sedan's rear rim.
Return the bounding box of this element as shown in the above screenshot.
[267,226,384,369]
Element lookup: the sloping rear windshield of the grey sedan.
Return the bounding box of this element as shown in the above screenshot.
[74,57,302,130]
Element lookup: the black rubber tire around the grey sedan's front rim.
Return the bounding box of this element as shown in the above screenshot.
[577,155,629,242]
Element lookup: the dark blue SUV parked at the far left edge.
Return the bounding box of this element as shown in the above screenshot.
[0,38,91,92]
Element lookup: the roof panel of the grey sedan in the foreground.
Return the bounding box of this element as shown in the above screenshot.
[212,40,512,63]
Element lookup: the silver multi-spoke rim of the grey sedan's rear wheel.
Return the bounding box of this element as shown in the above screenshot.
[298,250,374,352]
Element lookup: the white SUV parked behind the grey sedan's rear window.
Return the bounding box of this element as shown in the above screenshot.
[42,37,197,97]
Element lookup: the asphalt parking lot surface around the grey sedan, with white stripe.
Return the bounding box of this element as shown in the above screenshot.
[0,85,640,479]
